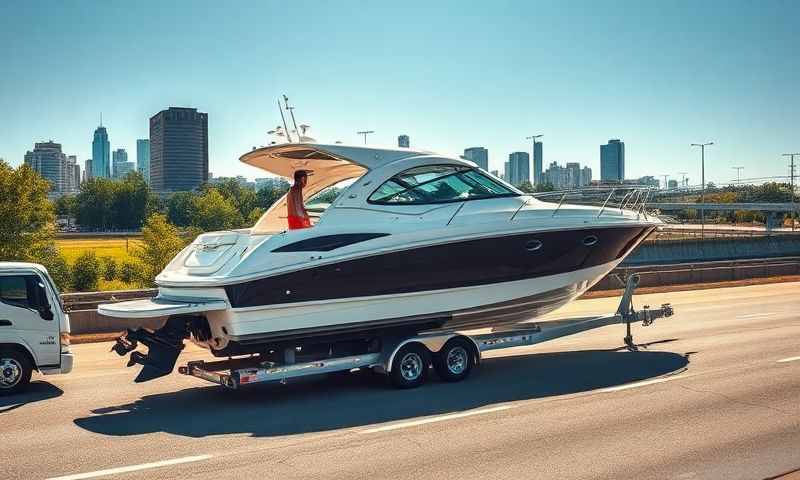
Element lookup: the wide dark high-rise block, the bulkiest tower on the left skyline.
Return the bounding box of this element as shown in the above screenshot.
[150,107,208,192]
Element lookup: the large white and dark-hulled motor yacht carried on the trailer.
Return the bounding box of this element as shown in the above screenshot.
[98,141,660,381]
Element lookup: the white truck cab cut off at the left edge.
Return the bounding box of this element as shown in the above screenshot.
[0,262,73,395]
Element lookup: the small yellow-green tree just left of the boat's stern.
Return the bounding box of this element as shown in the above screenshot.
[132,213,187,287]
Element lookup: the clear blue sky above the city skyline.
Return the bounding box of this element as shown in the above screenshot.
[0,0,800,183]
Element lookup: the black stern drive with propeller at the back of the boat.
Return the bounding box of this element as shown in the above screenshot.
[111,317,189,383]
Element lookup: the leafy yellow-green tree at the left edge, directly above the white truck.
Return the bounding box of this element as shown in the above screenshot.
[0,160,55,261]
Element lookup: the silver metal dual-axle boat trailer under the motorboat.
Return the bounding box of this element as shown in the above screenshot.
[178,275,673,390]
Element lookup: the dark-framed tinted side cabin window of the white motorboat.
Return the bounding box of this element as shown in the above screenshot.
[367,165,519,205]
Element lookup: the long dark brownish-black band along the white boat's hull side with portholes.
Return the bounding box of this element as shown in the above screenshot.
[225,225,655,308]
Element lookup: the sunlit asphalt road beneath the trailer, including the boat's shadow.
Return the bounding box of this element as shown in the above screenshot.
[0,283,800,480]
